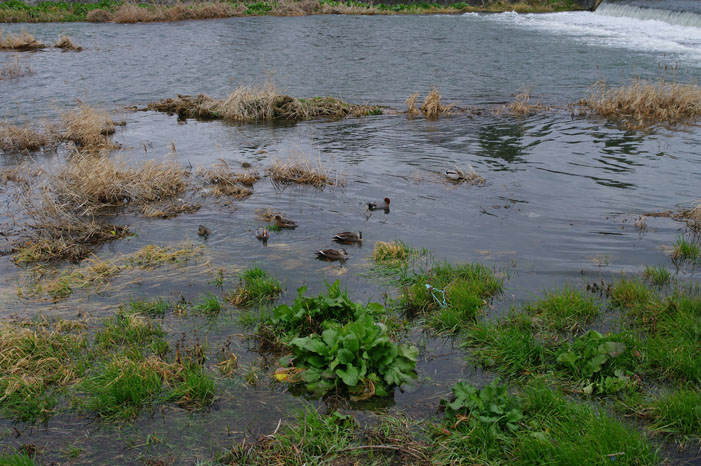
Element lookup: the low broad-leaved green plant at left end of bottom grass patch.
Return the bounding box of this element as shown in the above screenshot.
[445,378,523,432]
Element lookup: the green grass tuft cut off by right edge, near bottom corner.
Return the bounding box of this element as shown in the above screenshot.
[651,387,701,436]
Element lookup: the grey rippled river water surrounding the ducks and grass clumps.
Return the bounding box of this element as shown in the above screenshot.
[0,8,701,464]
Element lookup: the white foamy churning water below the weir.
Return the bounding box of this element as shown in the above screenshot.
[465,12,701,66]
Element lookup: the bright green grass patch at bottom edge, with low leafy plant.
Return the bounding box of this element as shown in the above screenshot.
[433,384,659,466]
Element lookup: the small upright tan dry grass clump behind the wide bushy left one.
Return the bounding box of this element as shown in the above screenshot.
[61,100,117,151]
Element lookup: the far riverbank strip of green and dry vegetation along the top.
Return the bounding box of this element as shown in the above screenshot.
[0,0,580,23]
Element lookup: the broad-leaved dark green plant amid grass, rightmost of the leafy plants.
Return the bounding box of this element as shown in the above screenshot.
[557,330,634,395]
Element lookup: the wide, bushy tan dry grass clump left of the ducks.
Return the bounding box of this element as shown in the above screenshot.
[50,154,186,215]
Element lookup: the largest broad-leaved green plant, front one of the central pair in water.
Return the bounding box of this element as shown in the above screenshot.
[280,314,419,400]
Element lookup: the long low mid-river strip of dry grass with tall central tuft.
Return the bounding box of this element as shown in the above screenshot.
[146,81,382,122]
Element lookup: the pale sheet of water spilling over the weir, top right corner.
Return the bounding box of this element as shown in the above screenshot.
[596,0,701,28]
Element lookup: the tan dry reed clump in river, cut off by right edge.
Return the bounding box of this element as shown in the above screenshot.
[579,79,701,129]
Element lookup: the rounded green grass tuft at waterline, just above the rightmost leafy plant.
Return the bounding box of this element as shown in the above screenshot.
[524,286,600,332]
